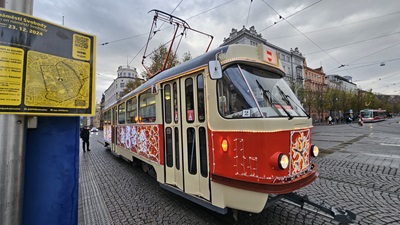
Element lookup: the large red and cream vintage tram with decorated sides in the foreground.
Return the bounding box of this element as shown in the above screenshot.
[104,45,318,213]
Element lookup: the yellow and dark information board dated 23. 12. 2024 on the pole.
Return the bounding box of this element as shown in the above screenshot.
[0,9,96,116]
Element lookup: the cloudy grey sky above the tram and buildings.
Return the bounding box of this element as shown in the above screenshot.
[33,0,400,102]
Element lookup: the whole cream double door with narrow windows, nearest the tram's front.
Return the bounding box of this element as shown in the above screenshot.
[163,74,210,200]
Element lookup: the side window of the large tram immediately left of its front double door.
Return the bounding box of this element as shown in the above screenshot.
[139,90,156,122]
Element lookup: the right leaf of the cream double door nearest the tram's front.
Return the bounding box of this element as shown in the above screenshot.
[181,74,210,200]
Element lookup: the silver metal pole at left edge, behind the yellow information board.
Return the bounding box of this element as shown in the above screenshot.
[0,0,33,225]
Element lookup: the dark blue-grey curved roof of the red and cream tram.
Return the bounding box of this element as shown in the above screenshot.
[120,46,229,101]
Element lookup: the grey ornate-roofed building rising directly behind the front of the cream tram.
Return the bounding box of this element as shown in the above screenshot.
[221,26,305,89]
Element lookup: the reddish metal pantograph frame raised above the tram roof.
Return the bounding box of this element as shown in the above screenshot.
[142,9,214,77]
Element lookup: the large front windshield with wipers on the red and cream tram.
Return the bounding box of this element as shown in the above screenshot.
[217,65,308,119]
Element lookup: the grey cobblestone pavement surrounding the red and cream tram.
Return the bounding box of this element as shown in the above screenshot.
[79,118,400,225]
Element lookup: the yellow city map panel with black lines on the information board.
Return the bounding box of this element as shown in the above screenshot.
[25,51,90,108]
